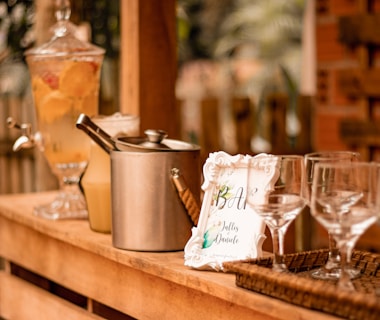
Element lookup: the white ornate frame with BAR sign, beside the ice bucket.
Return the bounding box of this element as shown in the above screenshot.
[184,151,266,271]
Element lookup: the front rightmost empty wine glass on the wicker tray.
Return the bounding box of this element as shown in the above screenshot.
[310,162,379,291]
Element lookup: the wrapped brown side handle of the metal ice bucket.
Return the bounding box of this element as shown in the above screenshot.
[170,168,200,226]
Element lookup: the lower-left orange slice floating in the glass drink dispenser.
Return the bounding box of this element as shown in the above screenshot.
[37,91,72,123]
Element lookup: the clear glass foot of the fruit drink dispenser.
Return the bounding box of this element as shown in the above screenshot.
[33,192,88,220]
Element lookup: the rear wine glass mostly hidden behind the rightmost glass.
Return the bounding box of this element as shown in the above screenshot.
[305,151,360,280]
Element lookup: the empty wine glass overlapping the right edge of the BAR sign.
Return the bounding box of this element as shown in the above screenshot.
[247,154,308,272]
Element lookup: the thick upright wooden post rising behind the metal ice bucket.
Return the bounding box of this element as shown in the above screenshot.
[120,0,178,137]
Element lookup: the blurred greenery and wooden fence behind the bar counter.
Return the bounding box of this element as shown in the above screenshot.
[0,0,314,192]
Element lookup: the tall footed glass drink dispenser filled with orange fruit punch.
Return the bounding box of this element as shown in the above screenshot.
[25,0,104,219]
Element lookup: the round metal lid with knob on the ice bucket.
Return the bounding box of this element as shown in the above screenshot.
[116,129,200,152]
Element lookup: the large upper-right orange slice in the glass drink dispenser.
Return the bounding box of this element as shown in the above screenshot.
[59,61,97,97]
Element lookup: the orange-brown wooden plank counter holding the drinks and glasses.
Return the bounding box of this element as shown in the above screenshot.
[0,192,337,320]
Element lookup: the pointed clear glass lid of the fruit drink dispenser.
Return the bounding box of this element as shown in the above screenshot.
[25,0,105,57]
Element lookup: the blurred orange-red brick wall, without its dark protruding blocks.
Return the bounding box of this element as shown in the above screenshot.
[312,0,380,160]
